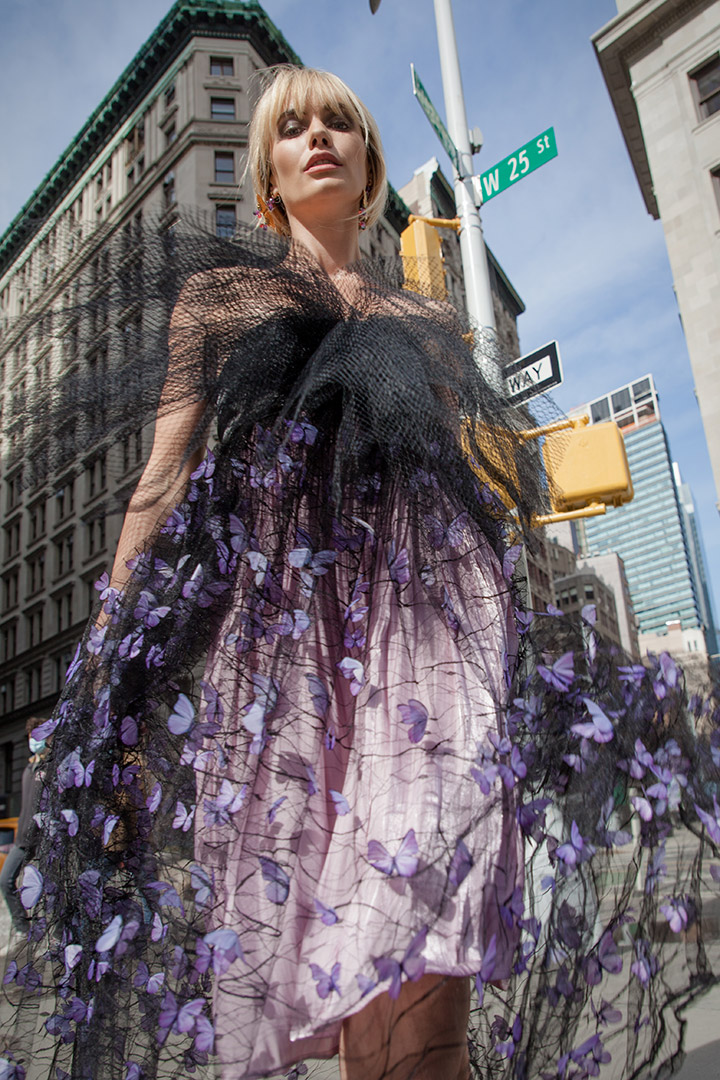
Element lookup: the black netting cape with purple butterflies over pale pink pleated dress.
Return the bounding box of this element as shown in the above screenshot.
[0,221,720,1080]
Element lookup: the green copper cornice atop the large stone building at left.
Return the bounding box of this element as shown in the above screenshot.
[0,0,301,273]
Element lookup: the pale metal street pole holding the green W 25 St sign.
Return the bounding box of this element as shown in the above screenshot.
[434,0,499,345]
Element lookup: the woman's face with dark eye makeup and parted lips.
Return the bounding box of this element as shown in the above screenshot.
[271,105,367,224]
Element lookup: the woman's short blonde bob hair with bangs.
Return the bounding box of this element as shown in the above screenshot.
[245,64,388,237]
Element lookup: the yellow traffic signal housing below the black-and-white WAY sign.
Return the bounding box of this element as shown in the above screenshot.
[543,417,633,514]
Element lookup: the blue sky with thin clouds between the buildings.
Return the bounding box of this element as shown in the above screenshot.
[0,0,720,630]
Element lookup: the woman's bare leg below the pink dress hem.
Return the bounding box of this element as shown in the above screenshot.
[340,975,470,1080]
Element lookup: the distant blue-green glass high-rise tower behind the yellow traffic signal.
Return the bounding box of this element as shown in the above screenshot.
[576,375,715,654]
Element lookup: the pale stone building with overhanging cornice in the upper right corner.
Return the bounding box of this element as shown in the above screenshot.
[593,0,720,509]
